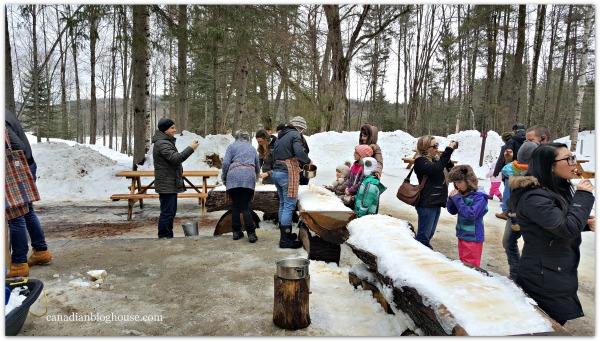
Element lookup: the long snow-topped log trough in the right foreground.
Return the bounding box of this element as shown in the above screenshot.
[346,215,569,336]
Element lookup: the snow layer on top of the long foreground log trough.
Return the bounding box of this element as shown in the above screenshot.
[347,215,552,336]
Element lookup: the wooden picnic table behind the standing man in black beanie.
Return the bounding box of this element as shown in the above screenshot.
[110,170,219,220]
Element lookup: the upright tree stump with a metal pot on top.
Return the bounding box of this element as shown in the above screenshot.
[273,274,310,330]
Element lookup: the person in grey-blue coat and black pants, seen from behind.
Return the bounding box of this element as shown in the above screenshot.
[221,131,260,243]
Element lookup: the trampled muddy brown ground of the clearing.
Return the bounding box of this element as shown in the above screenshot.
[15,201,595,336]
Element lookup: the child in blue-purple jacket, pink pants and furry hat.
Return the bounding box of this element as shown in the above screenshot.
[446,165,488,267]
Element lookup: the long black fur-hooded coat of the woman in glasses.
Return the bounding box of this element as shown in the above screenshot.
[508,176,594,321]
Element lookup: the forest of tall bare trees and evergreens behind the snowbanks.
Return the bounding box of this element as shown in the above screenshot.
[4,4,595,169]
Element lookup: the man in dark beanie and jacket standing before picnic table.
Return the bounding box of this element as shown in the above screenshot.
[152,118,198,238]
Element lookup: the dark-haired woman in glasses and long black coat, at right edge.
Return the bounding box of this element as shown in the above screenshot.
[508,143,595,325]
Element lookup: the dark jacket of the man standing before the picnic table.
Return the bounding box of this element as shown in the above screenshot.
[152,130,194,194]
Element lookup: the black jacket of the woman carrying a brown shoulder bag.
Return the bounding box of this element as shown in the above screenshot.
[414,146,454,208]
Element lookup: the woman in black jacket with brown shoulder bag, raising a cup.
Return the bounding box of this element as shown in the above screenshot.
[414,135,456,248]
